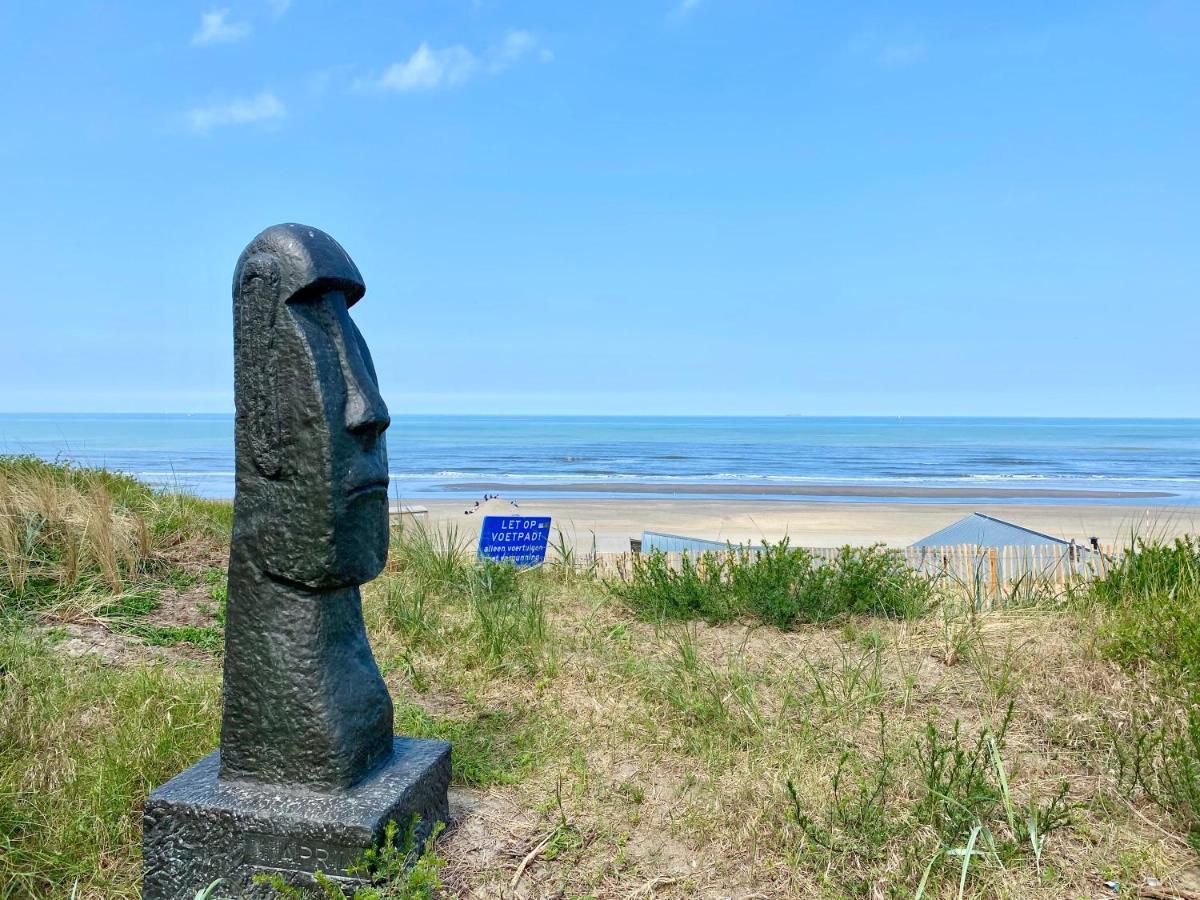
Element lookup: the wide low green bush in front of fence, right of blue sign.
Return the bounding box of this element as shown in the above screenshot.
[611,539,931,629]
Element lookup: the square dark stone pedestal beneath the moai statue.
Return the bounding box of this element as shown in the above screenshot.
[142,738,450,900]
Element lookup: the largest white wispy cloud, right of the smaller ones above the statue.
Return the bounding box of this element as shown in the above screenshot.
[355,31,554,92]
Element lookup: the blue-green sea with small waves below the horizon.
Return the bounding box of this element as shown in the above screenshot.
[0,413,1200,504]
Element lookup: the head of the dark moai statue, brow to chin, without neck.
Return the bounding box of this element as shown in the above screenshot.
[233,224,390,590]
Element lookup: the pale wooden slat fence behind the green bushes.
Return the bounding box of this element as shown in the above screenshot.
[561,544,1124,594]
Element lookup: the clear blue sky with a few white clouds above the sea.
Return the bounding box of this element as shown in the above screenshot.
[0,0,1200,415]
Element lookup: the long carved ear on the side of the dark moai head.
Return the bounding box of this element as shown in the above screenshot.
[234,253,282,478]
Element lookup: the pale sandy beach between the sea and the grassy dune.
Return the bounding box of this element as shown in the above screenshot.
[398,497,1200,552]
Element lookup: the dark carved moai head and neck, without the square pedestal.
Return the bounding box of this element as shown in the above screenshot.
[221,224,392,788]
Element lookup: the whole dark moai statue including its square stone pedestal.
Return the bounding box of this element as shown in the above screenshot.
[143,224,450,900]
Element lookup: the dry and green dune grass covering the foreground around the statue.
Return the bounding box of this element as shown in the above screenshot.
[0,463,1200,900]
